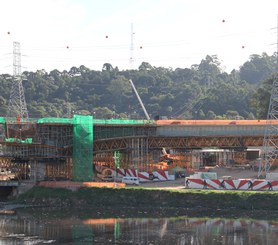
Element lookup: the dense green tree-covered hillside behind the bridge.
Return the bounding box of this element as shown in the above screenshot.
[0,53,277,119]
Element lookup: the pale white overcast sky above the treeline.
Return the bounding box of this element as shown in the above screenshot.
[0,0,278,74]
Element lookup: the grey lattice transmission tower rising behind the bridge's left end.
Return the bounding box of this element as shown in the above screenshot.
[7,42,28,119]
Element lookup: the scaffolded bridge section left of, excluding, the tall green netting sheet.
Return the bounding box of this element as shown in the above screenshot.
[0,118,73,180]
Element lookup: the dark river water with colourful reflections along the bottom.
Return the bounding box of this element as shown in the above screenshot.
[0,214,278,245]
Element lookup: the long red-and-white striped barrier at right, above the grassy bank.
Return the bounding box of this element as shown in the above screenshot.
[185,178,278,191]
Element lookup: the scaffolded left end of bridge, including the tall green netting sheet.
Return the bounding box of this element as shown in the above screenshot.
[0,115,93,181]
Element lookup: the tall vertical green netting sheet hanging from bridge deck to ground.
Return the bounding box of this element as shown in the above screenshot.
[73,115,93,181]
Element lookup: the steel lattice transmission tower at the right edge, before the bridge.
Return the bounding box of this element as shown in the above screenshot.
[258,74,278,177]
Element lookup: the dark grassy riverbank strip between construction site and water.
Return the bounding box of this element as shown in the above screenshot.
[12,186,278,213]
